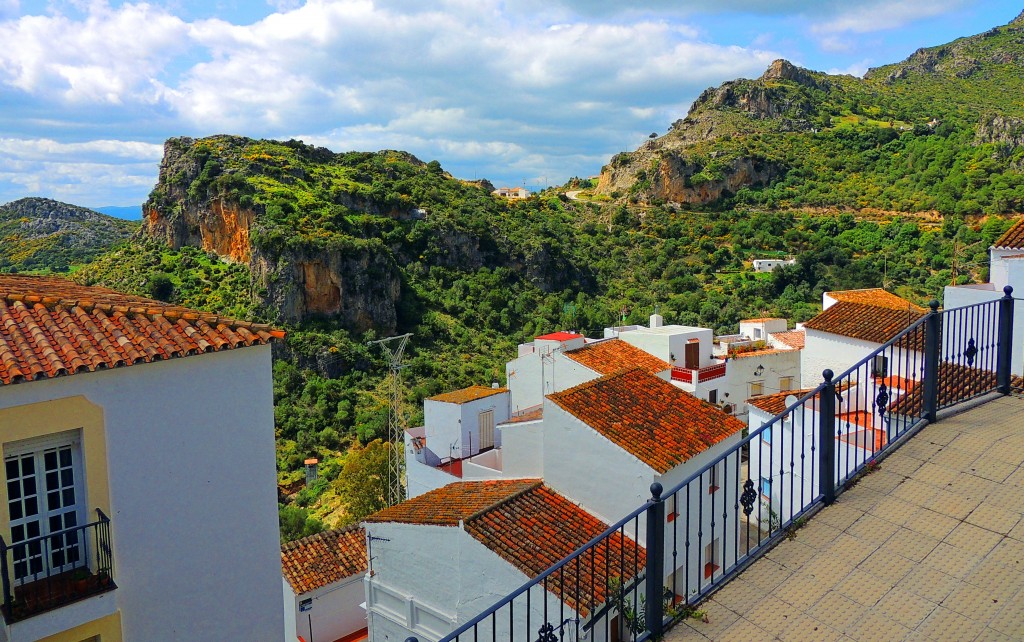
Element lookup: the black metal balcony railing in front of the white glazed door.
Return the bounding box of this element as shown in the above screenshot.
[0,508,117,625]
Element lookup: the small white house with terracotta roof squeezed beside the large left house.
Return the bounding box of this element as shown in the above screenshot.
[281,525,368,642]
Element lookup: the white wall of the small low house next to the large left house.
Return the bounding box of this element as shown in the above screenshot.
[282,572,367,642]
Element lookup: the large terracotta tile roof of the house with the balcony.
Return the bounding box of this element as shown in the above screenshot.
[0,274,285,384]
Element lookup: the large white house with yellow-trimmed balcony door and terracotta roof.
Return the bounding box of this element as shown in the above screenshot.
[0,274,287,642]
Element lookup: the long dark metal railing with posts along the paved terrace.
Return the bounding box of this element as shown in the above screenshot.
[407,287,1024,642]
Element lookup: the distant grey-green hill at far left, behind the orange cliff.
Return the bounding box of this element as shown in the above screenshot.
[0,198,138,272]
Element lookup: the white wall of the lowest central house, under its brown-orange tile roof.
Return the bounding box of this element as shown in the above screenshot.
[364,522,572,642]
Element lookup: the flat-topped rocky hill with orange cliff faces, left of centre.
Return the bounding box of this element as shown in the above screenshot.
[136,136,585,332]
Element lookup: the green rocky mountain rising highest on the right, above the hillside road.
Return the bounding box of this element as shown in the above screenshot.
[596,16,1024,214]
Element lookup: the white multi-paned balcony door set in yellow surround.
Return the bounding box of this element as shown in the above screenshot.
[4,440,86,585]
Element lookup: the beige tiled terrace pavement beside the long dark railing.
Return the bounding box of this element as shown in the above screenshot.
[665,397,1024,642]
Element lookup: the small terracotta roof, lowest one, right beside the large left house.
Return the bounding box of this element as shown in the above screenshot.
[281,526,367,595]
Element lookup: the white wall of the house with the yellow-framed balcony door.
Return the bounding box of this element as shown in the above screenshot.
[0,346,291,642]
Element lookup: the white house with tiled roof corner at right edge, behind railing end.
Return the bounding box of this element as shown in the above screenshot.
[943,217,1024,376]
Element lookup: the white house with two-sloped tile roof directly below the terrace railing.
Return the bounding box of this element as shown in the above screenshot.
[364,479,645,642]
